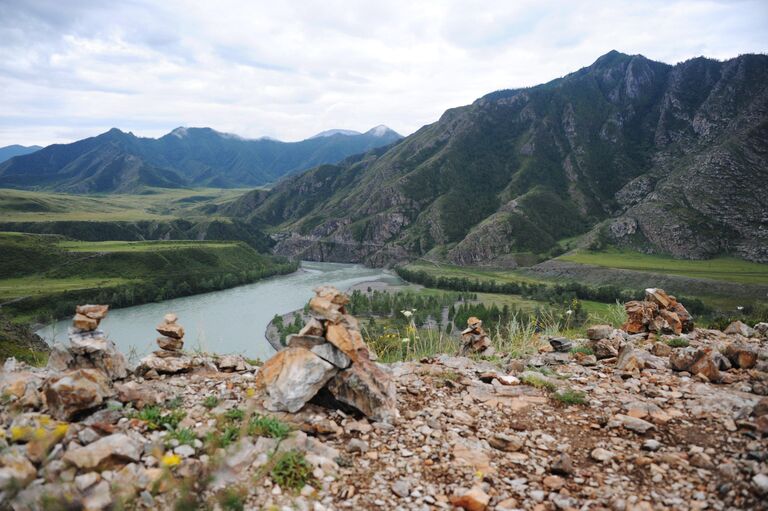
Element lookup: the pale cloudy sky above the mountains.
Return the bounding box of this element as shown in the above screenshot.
[0,0,768,146]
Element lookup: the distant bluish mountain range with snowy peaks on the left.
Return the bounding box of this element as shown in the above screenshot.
[0,126,402,193]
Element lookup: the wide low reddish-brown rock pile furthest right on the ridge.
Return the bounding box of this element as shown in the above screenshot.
[621,288,693,335]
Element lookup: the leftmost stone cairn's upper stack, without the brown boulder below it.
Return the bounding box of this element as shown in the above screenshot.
[48,305,128,380]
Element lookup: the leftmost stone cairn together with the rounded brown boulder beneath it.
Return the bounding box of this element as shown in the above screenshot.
[42,305,128,420]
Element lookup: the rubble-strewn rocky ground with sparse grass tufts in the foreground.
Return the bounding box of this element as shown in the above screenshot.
[0,306,768,511]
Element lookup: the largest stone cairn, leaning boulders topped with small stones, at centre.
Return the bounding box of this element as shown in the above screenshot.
[256,286,398,422]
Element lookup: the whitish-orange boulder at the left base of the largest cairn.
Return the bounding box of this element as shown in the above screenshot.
[256,348,338,413]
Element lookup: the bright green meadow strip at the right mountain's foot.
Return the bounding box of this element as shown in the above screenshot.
[557,249,768,284]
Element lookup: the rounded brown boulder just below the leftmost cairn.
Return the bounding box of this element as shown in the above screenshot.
[43,369,114,420]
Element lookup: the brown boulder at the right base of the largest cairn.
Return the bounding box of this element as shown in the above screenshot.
[328,358,398,423]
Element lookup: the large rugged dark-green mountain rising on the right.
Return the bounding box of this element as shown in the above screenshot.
[229,51,768,266]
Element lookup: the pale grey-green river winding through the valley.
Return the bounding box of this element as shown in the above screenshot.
[37,262,403,360]
